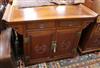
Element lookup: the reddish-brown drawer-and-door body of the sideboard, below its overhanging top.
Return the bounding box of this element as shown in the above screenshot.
[24,20,82,64]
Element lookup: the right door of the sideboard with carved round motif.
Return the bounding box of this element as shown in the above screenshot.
[55,28,80,57]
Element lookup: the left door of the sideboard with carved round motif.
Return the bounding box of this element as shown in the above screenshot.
[26,30,54,59]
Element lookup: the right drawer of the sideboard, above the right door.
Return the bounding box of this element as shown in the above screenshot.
[57,20,82,27]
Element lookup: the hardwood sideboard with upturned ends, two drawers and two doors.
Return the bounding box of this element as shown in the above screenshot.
[3,4,97,65]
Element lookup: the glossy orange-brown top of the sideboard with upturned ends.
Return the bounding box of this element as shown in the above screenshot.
[3,4,97,22]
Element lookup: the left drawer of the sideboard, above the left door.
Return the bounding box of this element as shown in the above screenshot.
[26,21,55,29]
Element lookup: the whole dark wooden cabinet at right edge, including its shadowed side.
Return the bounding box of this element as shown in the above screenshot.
[79,23,100,54]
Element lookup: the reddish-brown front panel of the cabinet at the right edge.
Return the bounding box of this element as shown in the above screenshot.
[81,24,100,52]
